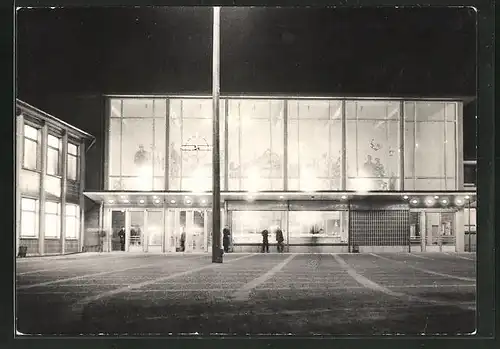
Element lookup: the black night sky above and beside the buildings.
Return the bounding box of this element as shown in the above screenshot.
[17,7,476,188]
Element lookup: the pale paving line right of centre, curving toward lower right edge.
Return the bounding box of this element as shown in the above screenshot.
[332,253,476,310]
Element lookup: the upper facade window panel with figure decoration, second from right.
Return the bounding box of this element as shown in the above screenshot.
[346,101,400,191]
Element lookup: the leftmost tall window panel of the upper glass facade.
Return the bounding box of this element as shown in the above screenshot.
[108,98,167,190]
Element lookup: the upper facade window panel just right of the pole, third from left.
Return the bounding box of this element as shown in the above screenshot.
[228,99,284,192]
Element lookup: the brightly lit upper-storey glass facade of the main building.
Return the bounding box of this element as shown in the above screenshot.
[106,98,462,192]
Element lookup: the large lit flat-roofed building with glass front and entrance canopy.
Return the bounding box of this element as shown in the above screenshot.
[84,95,476,252]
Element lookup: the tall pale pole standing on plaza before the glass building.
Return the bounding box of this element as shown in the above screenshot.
[212,6,222,263]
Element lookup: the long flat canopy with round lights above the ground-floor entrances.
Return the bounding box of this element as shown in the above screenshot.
[84,191,477,208]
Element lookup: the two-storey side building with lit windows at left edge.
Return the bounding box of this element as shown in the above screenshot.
[15,100,94,255]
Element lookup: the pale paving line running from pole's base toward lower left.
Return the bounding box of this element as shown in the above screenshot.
[71,253,255,314]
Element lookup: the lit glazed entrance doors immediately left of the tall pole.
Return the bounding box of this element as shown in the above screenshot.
[166,208,208,253]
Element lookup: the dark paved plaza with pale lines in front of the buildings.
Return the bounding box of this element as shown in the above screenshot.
[16,253,476,335]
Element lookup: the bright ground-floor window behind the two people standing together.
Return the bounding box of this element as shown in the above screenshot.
[232,211,286,244]
